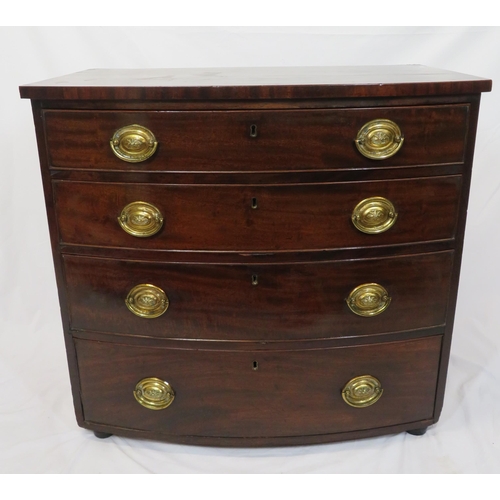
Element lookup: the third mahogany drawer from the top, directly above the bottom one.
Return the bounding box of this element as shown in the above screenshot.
[63,251,454,341]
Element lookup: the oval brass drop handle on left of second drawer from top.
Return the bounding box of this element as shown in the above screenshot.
[118,201,163,238]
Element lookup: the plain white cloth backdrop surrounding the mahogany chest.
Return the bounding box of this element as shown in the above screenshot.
[0,27,500,474]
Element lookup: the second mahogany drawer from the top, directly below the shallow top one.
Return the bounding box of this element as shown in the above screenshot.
[54,175,462,252]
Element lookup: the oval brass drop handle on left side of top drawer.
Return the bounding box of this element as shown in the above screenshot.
[110,124,158,163]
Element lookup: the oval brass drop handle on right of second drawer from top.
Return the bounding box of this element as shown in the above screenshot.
[351,196,398,234]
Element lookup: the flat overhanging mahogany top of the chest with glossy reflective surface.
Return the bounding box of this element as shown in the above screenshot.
[20,65,491,100]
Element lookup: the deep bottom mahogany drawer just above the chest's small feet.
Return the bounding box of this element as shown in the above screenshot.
[75,337,441,437]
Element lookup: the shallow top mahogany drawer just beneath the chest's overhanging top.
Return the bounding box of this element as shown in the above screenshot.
[43,104,469,172]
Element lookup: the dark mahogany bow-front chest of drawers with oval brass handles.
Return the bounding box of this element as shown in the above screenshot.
[20,66,491,446]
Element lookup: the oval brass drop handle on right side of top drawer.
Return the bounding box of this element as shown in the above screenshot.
[354,118,404,160]
